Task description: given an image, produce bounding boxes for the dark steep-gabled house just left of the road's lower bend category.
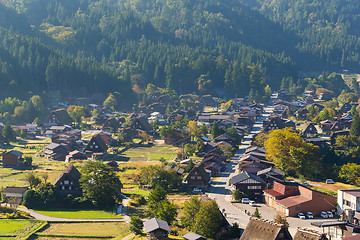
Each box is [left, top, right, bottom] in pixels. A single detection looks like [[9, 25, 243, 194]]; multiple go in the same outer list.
[[185, 163, 210, 190]]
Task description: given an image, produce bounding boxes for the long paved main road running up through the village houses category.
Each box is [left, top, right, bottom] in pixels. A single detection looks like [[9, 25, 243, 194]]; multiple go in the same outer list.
[[208, 94, 277, 228]]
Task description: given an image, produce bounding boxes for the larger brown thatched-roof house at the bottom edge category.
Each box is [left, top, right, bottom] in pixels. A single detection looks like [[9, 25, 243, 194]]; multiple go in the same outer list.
[[240, 218, 292, 240]]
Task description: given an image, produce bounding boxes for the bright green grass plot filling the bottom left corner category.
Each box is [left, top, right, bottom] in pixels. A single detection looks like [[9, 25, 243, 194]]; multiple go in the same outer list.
[[0, 219, 43, 239]]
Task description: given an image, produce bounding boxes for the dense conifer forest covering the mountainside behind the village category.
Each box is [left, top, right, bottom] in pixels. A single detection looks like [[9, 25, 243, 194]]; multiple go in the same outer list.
[[0, 0, 360, 101]]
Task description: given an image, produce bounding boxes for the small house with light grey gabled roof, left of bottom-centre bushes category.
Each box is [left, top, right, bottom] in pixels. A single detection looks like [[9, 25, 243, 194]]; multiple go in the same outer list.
[[144, 218, 171, 240]]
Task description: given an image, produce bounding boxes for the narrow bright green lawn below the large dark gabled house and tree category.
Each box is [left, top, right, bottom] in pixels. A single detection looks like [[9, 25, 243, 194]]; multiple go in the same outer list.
[[36, 210, 123, 219]]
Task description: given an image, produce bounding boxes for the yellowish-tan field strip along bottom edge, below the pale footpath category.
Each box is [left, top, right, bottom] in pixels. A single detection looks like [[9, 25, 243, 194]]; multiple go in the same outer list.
[[36, 222, 130, 239]]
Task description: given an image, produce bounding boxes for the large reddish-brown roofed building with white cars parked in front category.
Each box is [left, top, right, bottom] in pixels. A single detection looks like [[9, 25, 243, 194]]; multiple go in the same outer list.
[[264, 181, 336, 216]]
